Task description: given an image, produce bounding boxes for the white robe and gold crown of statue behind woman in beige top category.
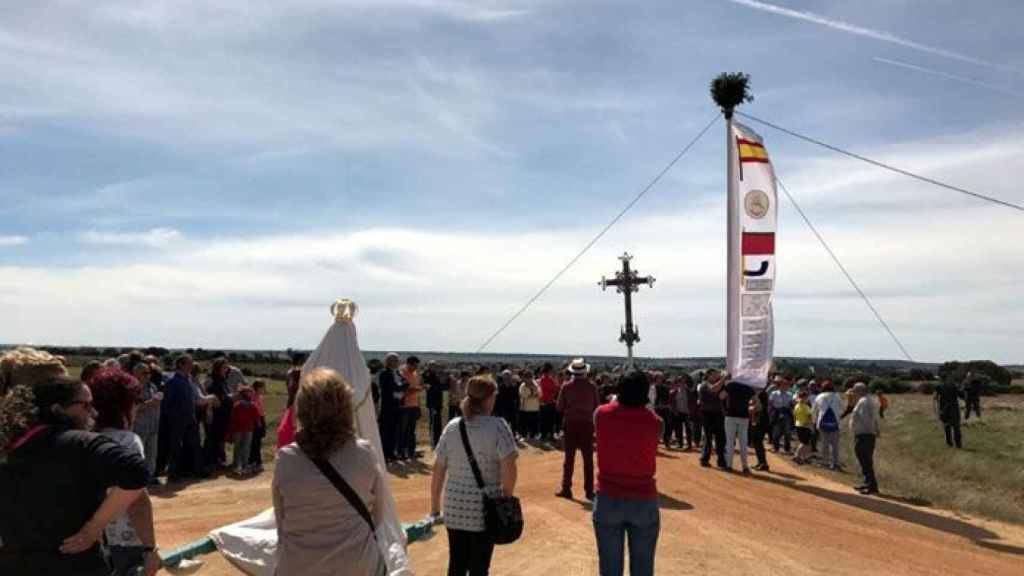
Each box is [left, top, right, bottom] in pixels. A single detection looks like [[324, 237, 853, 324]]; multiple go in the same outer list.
[[210, 300, 413, 576]]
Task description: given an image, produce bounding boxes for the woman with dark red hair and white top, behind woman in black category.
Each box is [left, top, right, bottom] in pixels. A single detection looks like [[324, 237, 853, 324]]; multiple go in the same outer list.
[[87, 368, 159, 576]]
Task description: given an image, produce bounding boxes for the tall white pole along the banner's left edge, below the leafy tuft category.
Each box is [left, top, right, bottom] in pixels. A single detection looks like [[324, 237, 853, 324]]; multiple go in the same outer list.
[[723, 109, 740, 374]]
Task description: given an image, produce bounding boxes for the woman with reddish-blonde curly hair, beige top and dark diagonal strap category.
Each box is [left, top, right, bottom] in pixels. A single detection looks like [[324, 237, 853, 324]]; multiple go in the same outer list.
[[271, 368, 387, 576]]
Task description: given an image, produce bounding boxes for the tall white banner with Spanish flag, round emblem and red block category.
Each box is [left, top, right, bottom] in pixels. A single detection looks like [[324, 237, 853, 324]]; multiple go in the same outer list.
[[726, 122, 778, 387]]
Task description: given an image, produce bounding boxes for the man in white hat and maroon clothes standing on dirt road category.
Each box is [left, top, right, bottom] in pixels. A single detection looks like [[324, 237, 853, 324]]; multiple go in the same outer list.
[[555, 358, 600, 500]]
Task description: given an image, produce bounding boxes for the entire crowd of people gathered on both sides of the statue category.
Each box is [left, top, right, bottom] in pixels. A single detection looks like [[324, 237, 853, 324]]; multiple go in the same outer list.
[[0, 340, 981, 576]]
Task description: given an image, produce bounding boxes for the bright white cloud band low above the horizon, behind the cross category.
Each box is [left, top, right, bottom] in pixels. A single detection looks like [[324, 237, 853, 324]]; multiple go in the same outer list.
[[0, 181, 1024, 361]]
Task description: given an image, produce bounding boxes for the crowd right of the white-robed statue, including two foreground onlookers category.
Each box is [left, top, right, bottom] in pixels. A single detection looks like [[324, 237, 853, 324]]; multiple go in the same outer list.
[[375, 354, 889, 576]]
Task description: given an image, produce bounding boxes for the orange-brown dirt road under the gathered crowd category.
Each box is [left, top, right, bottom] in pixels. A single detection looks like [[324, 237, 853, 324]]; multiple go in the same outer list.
[[154, 448, 1024, 576]]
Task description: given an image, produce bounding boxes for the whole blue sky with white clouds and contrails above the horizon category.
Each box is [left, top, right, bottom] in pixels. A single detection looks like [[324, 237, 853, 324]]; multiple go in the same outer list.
[[0, 0, 1024, 363]]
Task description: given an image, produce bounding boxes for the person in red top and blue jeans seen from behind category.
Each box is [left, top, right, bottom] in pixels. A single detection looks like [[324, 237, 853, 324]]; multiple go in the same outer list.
[[594, 371, 662, 576]]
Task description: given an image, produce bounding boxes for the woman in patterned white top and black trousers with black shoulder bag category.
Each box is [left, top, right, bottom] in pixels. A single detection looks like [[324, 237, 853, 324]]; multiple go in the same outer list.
[[430, 375, 518, 576]]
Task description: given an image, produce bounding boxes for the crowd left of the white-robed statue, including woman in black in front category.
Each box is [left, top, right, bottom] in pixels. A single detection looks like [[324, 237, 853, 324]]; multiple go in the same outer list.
[[0, 348, 266, 576]]
